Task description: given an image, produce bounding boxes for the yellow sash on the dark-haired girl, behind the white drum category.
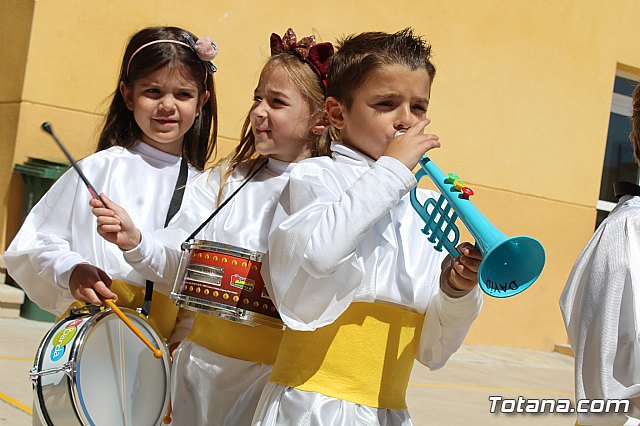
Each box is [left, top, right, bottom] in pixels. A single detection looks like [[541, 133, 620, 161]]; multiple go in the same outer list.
[[60, 280, 178, 342]]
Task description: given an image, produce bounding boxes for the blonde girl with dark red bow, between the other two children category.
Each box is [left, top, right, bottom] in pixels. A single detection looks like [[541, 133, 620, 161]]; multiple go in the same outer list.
[[92, 26, 333, 426]]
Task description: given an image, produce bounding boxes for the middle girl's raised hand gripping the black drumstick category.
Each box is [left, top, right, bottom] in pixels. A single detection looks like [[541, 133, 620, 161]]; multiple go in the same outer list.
[[89, 193, 142, 250]]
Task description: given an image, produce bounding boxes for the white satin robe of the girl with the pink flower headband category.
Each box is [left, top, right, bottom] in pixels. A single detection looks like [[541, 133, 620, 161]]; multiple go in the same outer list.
[[4, 143, 197, 315]]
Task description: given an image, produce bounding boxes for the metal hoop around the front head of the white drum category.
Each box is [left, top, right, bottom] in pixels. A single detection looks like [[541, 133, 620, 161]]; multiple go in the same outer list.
[[68, 308, 171, 424]]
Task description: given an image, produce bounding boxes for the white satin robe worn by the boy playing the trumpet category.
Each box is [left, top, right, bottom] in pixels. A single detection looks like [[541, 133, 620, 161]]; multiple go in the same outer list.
[[254, 143, 482, 426]]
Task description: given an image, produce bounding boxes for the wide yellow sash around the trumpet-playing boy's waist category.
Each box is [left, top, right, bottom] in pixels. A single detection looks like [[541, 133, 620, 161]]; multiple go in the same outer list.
[[269, 302, 424, 409]]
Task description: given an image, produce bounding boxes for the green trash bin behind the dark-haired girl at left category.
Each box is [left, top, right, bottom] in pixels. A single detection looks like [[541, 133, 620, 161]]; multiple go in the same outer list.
[[14, 157, 69, 322]]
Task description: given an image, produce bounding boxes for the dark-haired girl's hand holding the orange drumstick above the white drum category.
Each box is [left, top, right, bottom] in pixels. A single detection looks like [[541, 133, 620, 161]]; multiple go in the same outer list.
[[69, 263, 118, 306]]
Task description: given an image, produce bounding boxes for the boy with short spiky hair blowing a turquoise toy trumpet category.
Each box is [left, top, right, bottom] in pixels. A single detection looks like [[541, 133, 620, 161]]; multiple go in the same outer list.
[[253, 29, 482, 426]]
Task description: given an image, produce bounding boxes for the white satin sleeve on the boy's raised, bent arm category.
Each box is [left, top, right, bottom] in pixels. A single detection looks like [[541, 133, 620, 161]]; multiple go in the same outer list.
[[269, 157, 416, 330]]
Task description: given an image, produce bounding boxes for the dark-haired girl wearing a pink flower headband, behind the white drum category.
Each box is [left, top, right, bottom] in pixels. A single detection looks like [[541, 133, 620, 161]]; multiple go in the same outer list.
[[4, 22, 217, 380]]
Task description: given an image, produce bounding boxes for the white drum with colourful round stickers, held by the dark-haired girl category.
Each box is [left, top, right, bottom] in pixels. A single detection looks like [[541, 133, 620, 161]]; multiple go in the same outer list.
[[29, 308, 171, 426]]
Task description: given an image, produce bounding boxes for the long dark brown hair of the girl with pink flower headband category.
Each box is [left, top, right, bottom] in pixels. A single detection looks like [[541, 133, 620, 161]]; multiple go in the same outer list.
[[96, 27, 218, 170]]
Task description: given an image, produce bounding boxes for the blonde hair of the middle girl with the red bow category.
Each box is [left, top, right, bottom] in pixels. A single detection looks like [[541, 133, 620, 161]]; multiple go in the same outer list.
[[214, 52, 331, 204]]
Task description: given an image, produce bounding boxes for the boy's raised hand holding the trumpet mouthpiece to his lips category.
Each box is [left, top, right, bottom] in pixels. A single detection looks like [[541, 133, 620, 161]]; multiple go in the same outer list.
[[382, 117, 440, 170]]
